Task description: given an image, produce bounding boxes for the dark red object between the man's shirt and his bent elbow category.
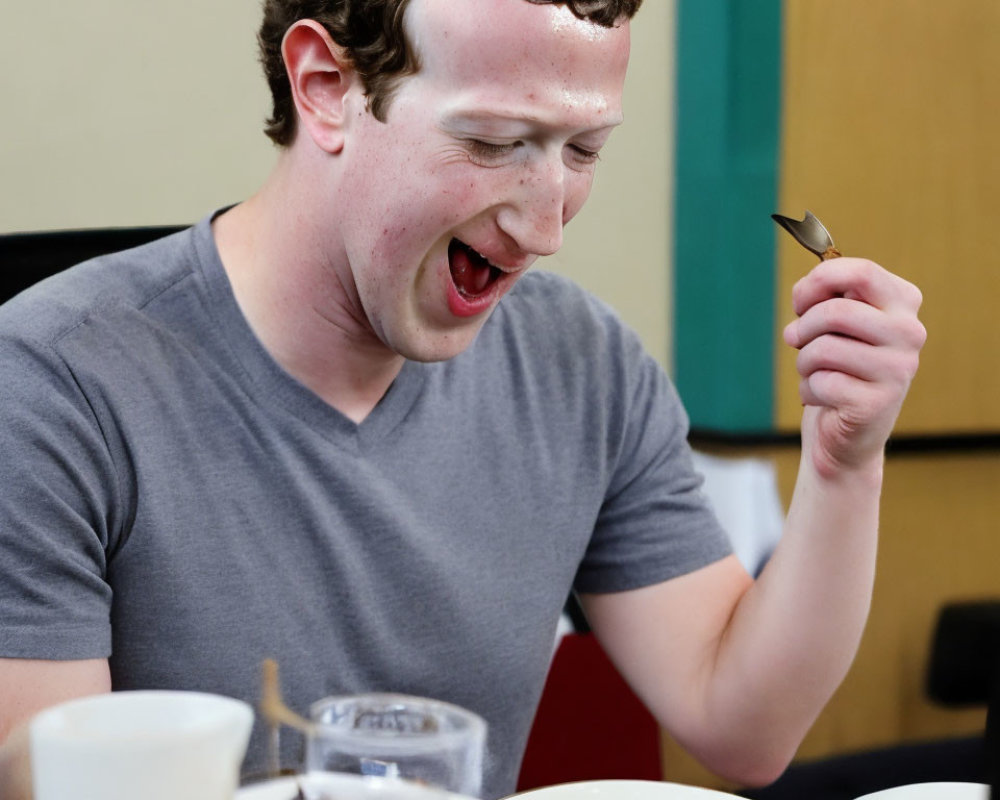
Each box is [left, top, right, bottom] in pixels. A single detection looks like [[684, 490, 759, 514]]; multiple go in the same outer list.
[[517, 633, 663, 791]]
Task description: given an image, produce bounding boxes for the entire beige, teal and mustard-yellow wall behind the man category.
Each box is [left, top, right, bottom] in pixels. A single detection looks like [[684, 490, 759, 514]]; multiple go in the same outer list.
[[0, 0, 1000, 785]]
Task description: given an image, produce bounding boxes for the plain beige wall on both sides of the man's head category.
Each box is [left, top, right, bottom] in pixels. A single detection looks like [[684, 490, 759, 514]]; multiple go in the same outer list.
[[0, 0, 674, 364]]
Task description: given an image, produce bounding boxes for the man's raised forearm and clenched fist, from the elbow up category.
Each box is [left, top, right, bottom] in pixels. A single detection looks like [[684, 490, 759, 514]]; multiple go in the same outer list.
[[699, 252, 927, 780]]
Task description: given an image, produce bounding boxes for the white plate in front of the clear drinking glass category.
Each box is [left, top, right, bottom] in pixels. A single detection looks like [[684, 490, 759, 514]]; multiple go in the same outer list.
[[236, 772, 471, 800]]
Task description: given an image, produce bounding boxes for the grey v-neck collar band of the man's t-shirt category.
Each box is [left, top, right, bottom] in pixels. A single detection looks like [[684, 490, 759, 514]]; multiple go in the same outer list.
[[193, 215, 427, 449]]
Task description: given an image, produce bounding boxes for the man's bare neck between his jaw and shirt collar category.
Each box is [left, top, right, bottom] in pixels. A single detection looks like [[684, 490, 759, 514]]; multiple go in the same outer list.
[[213, 150, 404, 423]]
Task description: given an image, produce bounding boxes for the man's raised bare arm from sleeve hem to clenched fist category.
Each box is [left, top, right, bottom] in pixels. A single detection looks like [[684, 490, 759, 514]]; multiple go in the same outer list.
[[582, 258, 925, 784]]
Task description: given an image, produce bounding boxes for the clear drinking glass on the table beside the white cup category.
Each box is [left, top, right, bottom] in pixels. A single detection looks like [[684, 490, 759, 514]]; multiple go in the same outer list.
[[306, 693, 486, 797]]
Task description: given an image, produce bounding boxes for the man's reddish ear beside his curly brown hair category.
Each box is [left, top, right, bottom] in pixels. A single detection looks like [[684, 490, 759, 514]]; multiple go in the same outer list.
[[281, 19, 359, 153]]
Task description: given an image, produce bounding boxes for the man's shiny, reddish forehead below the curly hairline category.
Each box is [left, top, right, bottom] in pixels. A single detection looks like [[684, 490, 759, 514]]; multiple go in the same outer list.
[[406, 0, 629, 124]]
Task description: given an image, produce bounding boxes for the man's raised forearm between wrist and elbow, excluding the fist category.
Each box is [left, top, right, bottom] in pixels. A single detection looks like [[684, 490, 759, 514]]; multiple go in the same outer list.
[[706, 455, 882, 782]]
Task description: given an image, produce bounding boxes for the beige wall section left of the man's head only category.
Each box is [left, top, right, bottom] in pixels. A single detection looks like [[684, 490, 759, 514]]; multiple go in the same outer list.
[[0, 0, 273, 231]]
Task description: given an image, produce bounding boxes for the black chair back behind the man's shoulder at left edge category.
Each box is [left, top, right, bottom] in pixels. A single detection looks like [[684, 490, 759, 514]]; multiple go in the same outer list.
[[0, 225, 185, 303]]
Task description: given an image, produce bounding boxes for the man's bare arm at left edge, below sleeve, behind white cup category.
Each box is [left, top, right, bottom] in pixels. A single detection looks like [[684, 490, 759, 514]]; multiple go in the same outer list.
[[0, 658, 111, 800]]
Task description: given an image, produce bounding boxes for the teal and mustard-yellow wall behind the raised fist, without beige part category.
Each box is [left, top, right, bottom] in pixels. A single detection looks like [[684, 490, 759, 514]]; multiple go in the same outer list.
[[665, 0, 1000, 798]]
